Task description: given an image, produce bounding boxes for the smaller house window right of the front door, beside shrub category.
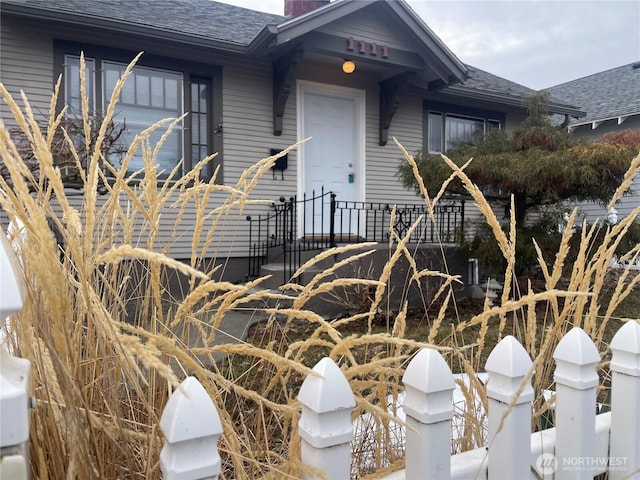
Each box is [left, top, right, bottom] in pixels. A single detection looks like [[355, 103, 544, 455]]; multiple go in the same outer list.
[[425, 103, 504, 153]]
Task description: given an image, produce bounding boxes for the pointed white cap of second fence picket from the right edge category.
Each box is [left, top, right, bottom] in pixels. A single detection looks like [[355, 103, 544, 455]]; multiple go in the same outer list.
[[553, 327, 600, 390]]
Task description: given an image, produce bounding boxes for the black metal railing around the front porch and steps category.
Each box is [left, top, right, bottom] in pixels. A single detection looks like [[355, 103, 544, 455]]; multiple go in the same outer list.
[[247, 189, 464, 283]]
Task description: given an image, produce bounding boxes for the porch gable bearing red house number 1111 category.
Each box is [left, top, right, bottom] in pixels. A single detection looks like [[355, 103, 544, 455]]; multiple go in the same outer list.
[[253, 0, 466, 90]]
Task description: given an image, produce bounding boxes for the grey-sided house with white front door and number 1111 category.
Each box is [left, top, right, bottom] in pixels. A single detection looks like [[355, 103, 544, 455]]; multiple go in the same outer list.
[[0, 0, 582, 280]]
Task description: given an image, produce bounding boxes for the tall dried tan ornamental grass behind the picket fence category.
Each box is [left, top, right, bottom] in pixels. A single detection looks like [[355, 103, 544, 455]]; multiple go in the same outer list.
[[0, 54, 640, 478]]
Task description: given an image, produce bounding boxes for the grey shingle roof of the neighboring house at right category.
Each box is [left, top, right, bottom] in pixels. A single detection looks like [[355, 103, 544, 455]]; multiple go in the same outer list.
[[547, 62, 640, 126]]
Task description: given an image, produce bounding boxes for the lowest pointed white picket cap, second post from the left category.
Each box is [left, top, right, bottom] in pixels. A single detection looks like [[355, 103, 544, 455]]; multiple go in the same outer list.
[[160, 377, 222, 443]]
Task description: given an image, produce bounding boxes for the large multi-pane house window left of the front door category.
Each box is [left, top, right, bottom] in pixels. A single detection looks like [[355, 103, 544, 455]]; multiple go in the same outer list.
[[56, 44, 222, 181]]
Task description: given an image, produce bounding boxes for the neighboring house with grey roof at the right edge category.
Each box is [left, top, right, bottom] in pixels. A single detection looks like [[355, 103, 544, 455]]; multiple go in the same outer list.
[[547, 62, 640, 222]]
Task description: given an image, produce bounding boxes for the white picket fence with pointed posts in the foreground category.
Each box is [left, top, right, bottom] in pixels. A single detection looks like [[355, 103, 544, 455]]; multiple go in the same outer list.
[[0, 235, 640, 480]]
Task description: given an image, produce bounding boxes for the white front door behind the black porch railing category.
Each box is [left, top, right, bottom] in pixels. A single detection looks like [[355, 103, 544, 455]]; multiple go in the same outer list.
[[299, 84, 364, 236]]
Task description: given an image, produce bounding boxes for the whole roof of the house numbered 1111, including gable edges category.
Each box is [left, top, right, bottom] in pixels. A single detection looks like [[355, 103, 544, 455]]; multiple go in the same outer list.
[[0, 0, 584, 116]]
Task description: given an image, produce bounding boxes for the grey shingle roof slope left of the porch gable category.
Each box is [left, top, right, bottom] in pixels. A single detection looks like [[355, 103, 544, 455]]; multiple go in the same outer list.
[[2, 0, 287, 46]]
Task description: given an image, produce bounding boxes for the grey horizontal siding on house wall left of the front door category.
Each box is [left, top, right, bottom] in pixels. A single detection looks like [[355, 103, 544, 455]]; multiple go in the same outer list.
[[0, 18, 276, 258]]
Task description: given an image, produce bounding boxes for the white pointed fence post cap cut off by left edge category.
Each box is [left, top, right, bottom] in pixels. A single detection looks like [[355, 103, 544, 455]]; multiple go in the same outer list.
[[0, 232, 27, 320]]
